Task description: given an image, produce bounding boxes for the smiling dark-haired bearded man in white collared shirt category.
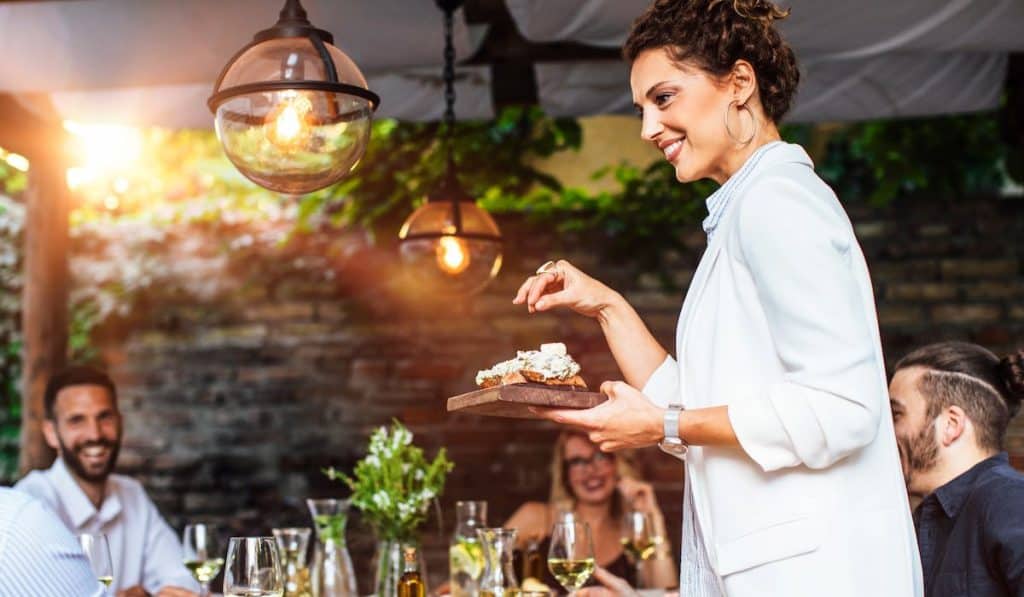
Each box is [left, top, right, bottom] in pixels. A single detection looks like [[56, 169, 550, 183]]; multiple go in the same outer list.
[[15, 367, 199, 597]]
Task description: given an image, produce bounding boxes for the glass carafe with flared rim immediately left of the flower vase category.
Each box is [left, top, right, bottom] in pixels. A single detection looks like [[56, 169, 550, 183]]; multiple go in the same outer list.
[[306, 500, 358, 597]]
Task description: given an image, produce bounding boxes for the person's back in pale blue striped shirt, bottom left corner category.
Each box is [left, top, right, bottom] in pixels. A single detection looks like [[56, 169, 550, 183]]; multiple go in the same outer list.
[[0, 487, 103, 597]]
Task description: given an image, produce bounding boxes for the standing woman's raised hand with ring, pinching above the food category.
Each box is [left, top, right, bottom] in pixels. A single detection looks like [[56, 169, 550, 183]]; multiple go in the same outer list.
[[512, 259, 617, 317]]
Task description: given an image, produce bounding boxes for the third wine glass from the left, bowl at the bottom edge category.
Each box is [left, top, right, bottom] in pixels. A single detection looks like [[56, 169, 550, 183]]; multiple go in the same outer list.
[[224, 537, 285, 597]]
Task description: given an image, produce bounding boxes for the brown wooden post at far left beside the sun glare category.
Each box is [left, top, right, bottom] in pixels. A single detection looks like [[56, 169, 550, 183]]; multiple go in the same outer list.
[[0, 95, 71, 474]]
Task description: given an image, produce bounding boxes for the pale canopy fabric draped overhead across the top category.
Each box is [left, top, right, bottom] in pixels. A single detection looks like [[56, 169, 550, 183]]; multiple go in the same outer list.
[[0, 0, 1024, 128]]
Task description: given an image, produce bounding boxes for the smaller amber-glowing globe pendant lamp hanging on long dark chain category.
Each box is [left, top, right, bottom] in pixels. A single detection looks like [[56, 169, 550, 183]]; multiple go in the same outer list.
[[398, 0, 502, 295]]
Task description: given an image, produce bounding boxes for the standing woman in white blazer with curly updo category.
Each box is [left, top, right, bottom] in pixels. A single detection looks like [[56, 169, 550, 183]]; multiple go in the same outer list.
[[514, 0, 922, 597]]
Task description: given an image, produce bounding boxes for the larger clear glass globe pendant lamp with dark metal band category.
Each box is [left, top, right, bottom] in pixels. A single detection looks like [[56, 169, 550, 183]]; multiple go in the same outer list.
[[207, 0, 380, 195]]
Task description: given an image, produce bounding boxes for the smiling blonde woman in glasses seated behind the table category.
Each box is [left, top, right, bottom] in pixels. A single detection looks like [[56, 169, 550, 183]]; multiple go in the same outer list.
[[505, 431, 679, 591]]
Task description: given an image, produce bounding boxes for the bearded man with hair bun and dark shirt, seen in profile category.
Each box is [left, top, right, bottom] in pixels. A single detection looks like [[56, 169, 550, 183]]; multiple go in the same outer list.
[[889, 342, 1024, 597]]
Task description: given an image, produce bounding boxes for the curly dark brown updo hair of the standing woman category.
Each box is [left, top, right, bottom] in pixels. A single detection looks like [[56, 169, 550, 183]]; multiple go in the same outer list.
[[623, 0, 800, 123]]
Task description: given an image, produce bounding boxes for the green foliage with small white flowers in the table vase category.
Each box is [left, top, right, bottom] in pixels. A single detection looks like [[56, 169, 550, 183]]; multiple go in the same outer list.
[[324, 421, 455, 541]]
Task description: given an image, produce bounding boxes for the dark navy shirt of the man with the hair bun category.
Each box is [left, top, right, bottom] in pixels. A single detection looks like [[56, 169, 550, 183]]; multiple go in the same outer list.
[[913, 453, 1024, 597]]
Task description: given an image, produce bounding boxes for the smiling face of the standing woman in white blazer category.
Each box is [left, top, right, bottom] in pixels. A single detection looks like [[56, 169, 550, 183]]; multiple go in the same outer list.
[[630, 47, 736, 182]]
